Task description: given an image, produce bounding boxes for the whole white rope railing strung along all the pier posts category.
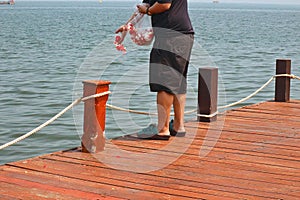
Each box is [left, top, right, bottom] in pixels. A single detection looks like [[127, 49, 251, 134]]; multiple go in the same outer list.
[[0, 74, 300, 150]]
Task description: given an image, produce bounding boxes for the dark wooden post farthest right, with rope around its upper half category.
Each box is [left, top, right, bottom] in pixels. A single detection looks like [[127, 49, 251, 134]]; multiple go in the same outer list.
[[275, 59, 291, 102]]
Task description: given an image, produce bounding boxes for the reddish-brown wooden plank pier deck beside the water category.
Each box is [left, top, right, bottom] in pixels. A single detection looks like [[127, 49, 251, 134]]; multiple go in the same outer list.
[[0, 100, 300, 200]]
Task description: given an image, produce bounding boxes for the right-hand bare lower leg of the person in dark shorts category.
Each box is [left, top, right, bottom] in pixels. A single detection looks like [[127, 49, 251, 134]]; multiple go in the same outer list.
[[173, 94, 186, 132]]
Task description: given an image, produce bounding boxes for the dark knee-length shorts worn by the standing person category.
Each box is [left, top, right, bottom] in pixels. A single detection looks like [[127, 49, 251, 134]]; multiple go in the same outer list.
[[149, 34, 194, 94]]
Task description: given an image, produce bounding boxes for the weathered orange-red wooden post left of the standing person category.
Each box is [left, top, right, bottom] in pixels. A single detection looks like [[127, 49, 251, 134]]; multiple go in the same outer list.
[[81, 81, 111, 153]]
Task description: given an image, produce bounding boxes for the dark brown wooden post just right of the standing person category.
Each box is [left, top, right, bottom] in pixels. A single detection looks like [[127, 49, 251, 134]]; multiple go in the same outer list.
[[197, 68, 218, 122]]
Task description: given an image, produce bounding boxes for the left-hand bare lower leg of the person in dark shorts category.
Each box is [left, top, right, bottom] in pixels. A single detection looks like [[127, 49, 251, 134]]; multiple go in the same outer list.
[[157, 91, 174, 135]]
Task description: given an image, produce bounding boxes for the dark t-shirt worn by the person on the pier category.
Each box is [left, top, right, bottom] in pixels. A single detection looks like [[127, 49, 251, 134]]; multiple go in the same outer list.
[[143, 0, 194, 34]]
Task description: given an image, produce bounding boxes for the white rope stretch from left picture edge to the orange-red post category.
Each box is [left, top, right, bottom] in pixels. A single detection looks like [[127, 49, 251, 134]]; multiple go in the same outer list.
[[0, 91, 111, 150]]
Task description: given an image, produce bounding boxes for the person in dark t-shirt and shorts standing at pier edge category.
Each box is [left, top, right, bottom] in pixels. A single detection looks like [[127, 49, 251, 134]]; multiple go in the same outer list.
[[116, 0, 194, 140]]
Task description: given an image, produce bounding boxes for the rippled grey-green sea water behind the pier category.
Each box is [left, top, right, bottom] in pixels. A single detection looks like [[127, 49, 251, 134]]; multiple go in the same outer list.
[[0, 1, 300, 164]]
